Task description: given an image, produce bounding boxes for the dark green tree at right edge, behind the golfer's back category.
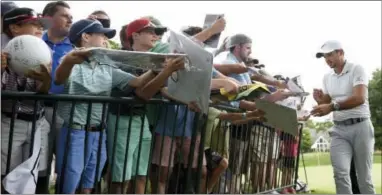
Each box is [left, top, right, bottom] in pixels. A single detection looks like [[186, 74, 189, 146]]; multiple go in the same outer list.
[[369, 69, 382, 150]]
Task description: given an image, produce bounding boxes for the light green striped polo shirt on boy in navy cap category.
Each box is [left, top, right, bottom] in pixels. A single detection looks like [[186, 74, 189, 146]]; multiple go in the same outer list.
[[58, 56, 135, 125]]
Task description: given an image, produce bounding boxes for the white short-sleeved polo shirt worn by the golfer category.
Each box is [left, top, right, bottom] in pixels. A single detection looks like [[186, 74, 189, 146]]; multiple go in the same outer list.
[[322, 62, 370, 121]]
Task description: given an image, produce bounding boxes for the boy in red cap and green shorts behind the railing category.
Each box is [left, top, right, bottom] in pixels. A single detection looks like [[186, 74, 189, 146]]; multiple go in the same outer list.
[[108, 18, 180, 193]]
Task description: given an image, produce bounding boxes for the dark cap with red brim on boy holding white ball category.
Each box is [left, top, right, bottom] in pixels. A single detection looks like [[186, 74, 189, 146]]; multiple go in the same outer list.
[[3, 8, 52, 29]]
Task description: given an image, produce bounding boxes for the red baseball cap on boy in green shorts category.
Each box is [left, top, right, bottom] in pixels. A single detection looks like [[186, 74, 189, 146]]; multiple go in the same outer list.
[[126, 18, 167, 38]]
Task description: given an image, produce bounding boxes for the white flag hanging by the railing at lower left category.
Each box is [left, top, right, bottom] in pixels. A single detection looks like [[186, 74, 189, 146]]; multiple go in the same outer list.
[[3, 128, 41, 194]]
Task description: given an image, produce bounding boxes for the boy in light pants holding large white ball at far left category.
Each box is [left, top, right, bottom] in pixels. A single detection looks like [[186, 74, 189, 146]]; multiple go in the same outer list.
[[1, 8, 52, 193]]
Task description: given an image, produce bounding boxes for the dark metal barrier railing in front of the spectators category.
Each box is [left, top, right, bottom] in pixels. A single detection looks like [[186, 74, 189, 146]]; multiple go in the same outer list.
[[1, 91, 301, 194]]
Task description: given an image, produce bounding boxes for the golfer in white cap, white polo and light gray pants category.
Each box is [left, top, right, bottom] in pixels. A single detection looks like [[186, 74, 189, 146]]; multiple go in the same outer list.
[[311, 41, 375, 194]]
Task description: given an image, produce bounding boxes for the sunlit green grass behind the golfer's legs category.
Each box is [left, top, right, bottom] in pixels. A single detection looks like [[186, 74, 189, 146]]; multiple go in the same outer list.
[[299, 152, 382, 194]]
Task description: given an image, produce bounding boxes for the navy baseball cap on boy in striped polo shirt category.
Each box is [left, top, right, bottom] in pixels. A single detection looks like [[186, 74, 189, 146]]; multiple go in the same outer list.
[[69, 19, 117, 43]]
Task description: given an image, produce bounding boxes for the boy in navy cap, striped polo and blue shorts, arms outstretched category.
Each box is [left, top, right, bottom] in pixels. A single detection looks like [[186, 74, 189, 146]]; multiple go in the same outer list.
[[55, 19, 187, 193]]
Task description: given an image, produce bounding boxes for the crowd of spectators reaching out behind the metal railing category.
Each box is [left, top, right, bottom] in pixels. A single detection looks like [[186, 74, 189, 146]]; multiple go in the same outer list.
[[1, 1, 307, 194]]
